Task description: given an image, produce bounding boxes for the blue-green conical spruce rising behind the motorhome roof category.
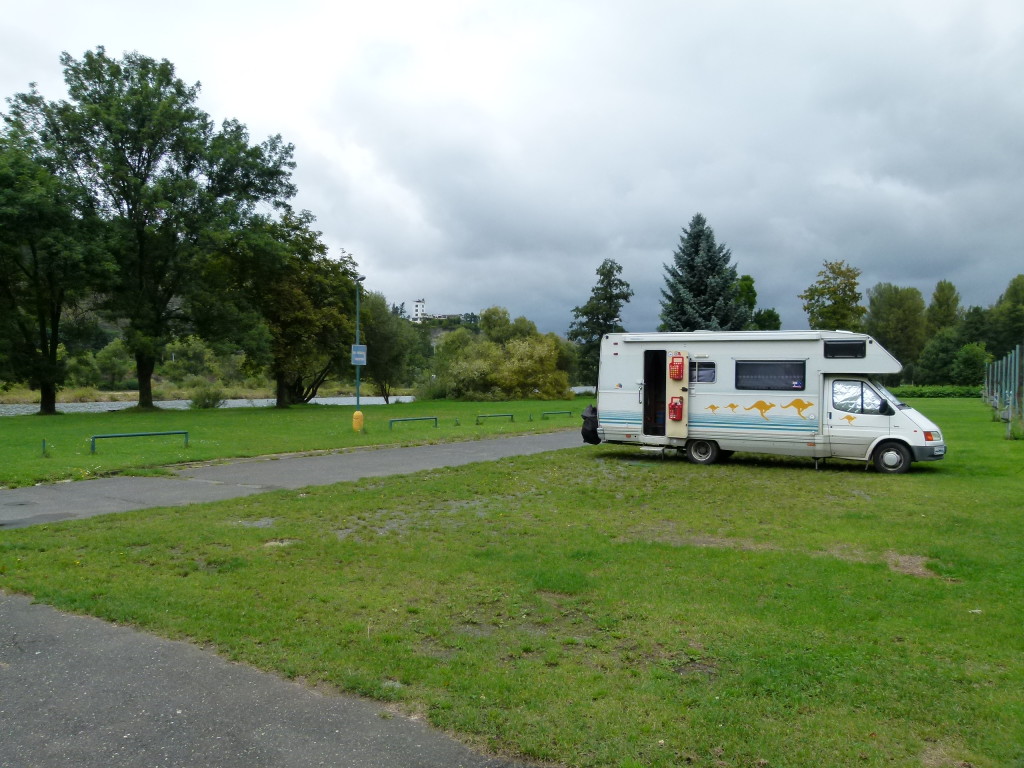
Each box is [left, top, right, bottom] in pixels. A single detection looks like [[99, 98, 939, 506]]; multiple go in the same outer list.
[[658, 213, 751, 331]]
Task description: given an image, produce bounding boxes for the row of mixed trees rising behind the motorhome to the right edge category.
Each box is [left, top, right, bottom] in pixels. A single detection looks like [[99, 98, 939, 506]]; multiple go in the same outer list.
[[568, 213, 1024, 386]]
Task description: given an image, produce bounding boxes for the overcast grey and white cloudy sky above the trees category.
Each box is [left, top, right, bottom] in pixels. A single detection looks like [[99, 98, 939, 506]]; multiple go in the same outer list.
[[0, 0, 1024, 333]]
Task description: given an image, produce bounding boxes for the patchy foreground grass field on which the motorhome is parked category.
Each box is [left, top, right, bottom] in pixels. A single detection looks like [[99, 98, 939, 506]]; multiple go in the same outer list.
[[0, 400, 1024, 768]]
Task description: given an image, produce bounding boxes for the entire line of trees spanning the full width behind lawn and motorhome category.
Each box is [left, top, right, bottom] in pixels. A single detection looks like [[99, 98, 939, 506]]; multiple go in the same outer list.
[[0, 47, 1024, 414]]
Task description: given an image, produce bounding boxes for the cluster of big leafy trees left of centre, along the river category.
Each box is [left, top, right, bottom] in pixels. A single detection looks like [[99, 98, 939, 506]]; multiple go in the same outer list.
[[0, 47, 444, 414]]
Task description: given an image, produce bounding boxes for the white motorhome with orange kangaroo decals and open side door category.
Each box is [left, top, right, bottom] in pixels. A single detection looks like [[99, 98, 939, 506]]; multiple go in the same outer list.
[[597, 331, 946, 473]]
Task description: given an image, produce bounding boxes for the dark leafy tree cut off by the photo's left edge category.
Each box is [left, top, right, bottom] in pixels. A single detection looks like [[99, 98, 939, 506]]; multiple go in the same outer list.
[[0, 123, 108, 414]]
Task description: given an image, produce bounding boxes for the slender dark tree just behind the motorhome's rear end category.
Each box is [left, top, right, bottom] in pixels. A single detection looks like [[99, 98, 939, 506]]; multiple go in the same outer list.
[[567, 259, 633, 386]]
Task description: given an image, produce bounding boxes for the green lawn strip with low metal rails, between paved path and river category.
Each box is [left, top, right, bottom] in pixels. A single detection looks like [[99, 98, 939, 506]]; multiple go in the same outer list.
[[0, 398, 590, 486]]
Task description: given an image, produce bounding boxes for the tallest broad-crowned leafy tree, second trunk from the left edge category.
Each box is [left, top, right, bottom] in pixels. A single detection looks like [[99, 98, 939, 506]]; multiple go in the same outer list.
[[11, 47, 294, 407]]
